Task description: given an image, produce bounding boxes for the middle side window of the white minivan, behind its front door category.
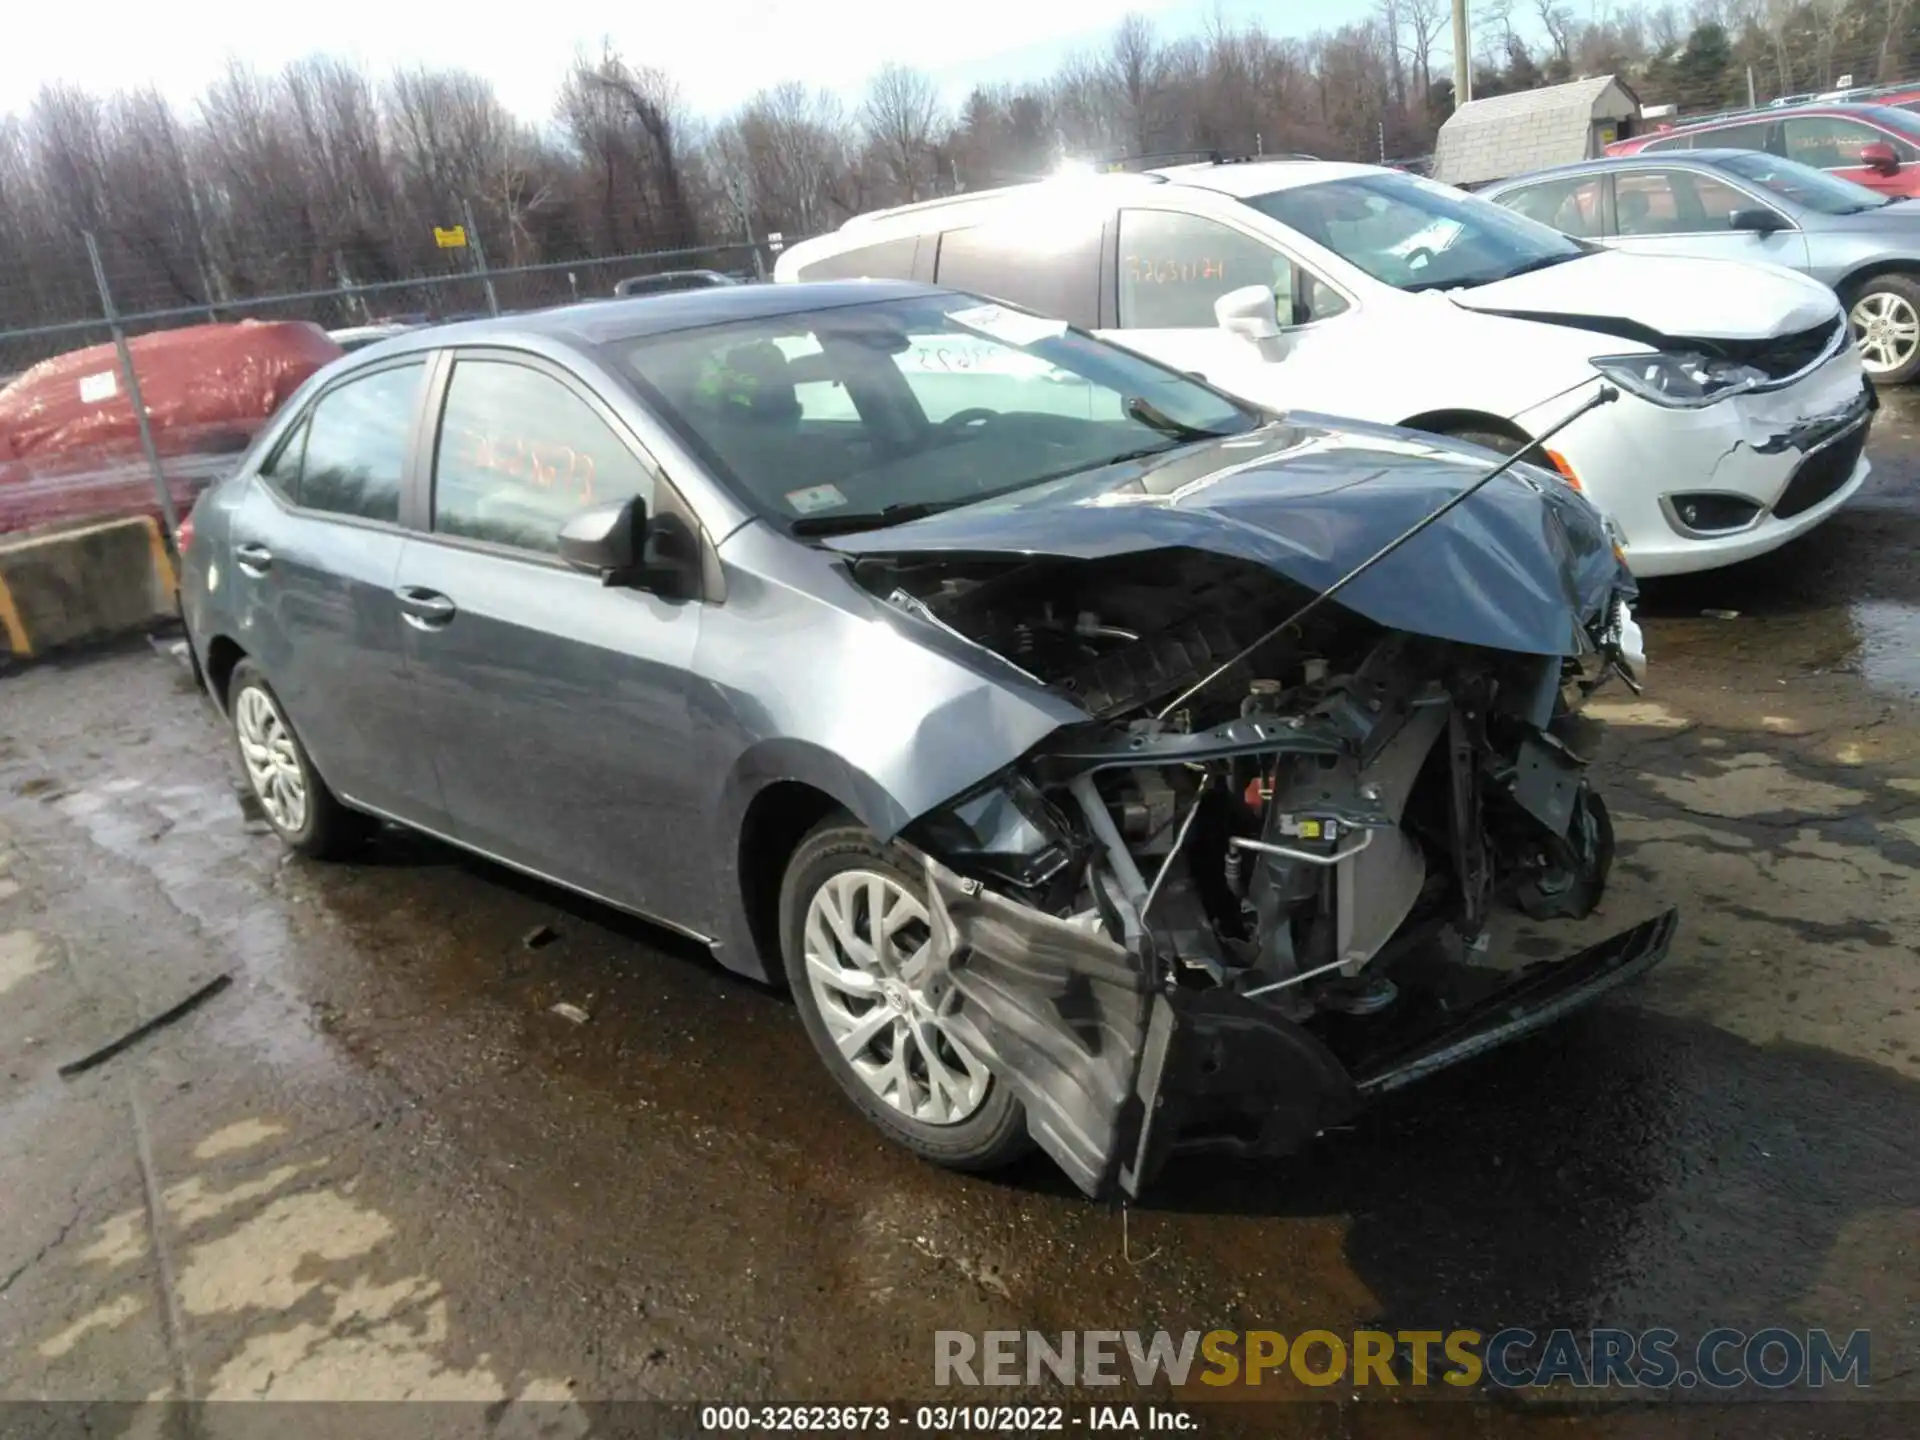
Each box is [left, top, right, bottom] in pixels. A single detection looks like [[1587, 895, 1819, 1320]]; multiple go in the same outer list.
[[933, 211, 1102, 330]]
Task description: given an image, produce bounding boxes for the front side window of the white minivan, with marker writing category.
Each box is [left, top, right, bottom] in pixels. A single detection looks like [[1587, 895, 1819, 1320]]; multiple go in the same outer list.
[[1119, 209, 1346, 330]]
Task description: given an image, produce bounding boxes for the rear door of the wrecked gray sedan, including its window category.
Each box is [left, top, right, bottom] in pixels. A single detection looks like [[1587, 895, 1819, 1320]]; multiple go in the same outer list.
[[219, 355, 440, 828]]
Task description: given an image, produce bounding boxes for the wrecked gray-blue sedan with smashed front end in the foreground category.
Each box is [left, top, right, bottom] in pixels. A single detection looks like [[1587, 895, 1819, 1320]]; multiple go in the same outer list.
[[182, 282, 1674, 1194]]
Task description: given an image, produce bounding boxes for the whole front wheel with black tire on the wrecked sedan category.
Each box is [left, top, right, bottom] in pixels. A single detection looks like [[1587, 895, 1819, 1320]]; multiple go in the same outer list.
[[780, 816, 1031, 1171]]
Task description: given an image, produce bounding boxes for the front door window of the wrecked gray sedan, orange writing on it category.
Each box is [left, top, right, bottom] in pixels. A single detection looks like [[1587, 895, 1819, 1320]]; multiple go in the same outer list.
[[434, 359, 653, 555]]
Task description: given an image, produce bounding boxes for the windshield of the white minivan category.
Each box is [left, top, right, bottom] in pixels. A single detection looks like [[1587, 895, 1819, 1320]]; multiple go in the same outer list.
[[1246, 171, 1586, 290]]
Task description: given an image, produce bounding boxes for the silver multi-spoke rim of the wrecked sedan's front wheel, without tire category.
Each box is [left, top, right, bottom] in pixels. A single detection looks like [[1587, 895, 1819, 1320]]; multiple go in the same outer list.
[[803, 870, 991, 1125]]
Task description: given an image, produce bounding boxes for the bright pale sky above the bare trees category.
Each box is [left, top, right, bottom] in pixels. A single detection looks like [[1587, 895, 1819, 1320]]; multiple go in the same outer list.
[[0, 0, 1413, 121]]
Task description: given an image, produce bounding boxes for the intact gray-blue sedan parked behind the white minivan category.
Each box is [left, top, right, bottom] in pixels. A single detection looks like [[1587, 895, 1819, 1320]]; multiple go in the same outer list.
[[1482, 150, 1920, 384]]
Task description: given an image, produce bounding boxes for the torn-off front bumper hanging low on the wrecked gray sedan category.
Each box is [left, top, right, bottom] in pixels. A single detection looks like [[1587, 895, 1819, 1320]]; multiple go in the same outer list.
[[924, 856, 1678, 1196]]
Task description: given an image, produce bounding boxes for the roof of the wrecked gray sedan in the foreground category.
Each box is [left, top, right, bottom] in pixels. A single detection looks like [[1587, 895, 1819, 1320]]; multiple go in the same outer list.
[[361, 280, 948, 357]]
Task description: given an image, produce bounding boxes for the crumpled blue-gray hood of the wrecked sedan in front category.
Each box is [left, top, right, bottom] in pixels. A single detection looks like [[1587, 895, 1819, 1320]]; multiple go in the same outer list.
[[822, 415, 1632, 655]]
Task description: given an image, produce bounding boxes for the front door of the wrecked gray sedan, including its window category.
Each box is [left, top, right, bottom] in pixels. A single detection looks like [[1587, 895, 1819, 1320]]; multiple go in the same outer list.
[[394, 349, 707, 924]]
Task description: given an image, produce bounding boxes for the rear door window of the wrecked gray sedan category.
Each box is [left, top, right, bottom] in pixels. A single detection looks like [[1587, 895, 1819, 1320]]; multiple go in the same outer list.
[[298, 361, 426, 522]]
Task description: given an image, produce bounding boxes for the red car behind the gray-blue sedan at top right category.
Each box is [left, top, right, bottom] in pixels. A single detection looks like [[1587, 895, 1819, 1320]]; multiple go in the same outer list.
[[1607, 104, 1920, 196]]
